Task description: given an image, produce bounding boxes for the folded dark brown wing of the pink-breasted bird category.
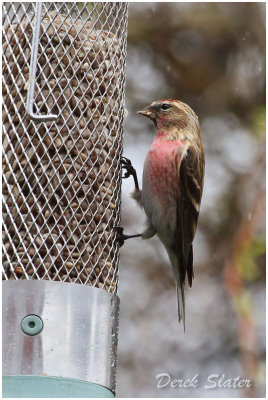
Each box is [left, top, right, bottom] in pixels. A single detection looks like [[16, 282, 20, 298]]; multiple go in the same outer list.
[[174, 144, 204, 287]]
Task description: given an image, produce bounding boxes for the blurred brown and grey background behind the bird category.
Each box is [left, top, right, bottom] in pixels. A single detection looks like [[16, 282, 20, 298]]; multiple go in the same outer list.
[[117, 2, 265, 397]]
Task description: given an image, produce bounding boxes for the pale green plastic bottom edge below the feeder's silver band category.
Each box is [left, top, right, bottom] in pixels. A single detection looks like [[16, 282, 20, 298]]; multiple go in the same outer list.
[[2, 375, 114, 398]]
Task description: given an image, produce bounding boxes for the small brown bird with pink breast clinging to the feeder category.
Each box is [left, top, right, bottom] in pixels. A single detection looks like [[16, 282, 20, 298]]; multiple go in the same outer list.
[[120, 99, 205, 331]]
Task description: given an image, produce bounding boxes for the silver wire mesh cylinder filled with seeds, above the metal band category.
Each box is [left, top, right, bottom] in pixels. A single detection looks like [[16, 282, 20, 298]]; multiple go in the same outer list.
[[3, 2, 127, 292]]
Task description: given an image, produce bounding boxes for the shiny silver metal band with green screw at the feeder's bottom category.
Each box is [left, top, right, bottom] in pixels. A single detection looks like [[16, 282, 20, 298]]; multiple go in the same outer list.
[[2, 279, 119, 397]]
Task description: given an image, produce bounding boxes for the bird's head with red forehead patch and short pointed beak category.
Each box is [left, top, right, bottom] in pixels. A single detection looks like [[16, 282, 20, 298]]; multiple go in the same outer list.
[[138, 99, 199, 134]]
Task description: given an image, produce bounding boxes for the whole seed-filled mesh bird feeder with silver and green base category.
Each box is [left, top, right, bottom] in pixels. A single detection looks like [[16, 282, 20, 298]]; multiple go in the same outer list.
[[2, 2, 127, 397]]
